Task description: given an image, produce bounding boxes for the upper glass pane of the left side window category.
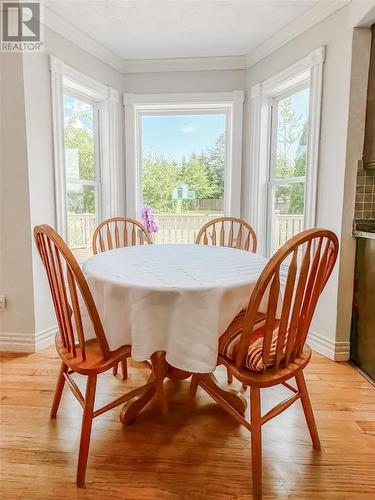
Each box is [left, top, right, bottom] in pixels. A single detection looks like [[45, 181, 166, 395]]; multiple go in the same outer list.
[[64, 95, 95, 180]]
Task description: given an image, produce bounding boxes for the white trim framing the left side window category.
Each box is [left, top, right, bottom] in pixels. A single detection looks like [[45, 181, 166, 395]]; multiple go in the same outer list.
[[50, 56, 119, 239]]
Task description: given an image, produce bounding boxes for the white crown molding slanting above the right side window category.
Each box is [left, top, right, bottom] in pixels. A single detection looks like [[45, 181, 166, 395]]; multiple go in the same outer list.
[[246, 0, 351, 68]]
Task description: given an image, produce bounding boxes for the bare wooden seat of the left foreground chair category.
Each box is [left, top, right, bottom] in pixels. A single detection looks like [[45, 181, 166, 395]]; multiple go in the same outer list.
[[55, 333, 131, 375]]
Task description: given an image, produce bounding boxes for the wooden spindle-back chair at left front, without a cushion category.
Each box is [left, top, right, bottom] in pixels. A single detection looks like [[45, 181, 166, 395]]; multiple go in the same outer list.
[[34, 225, 153, 486]]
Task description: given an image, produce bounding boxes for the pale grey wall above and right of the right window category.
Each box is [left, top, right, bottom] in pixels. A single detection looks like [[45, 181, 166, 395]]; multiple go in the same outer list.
[[242, 2, 369, 359]]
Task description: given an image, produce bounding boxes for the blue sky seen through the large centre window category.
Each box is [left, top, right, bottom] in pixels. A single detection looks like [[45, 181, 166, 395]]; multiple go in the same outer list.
[[142, 114, 225, 162]]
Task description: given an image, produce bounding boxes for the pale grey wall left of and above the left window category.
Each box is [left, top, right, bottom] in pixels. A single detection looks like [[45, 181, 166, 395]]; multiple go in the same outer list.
[[0, 29, 124, 350]]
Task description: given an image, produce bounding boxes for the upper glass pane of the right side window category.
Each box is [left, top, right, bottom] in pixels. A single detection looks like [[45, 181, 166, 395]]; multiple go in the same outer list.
[[275, 88, 309, 178]]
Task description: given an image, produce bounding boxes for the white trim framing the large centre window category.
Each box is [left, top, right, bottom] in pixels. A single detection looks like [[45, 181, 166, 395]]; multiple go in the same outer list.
[[123, 90, 244, 217]]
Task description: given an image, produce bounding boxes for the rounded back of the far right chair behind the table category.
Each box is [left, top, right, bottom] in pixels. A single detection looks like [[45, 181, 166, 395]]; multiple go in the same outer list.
[[195, 217, 257, 253]]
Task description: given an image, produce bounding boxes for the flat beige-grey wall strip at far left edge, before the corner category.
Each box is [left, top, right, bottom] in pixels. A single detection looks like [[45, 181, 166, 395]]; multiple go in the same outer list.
[[0, 53, 34, 350]]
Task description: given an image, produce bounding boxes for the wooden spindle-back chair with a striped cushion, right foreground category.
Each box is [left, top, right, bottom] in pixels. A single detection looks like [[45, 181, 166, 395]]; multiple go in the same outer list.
[[191, 229, 338, 500]]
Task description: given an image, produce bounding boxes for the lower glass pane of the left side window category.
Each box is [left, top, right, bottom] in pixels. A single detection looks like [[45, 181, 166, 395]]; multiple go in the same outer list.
[[66, 183, 97, 256]]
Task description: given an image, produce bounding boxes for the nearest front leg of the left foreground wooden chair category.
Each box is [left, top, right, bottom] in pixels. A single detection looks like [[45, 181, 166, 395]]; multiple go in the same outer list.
[[76, 375, 97, 487]]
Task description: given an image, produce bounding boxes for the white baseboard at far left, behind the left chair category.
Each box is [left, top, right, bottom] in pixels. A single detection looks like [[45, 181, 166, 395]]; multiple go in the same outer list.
[[0, 326, 57, 352]]
